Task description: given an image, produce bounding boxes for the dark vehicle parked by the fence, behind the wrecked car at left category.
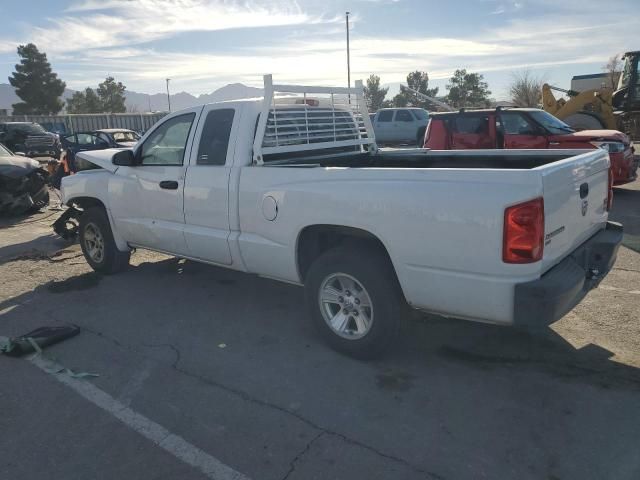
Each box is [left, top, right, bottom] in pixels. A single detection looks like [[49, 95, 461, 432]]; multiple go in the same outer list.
[[0, 122, 60, 158]]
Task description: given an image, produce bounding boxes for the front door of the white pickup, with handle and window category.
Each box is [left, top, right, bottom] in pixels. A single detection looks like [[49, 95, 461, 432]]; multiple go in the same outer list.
[[111, 106, 202, 255]]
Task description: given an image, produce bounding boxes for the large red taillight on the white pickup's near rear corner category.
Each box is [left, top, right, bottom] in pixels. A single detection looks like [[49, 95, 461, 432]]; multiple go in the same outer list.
[[502, 197, 544, 263]]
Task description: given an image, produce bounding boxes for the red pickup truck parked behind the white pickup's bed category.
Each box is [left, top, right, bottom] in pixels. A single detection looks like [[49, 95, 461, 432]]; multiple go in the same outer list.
[[424, 107, 638, 185]]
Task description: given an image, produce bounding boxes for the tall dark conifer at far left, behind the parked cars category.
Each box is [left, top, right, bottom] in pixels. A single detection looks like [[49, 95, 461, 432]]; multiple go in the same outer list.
[[9, 43, 66, 115]]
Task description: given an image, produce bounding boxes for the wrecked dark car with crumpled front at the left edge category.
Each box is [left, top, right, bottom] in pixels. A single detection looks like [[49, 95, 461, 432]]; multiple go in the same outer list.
[[0, 144, 49, 215]]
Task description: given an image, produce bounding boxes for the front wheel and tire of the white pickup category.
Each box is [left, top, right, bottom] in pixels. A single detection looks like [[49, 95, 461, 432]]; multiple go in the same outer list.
[[79, 207, 131, 275]]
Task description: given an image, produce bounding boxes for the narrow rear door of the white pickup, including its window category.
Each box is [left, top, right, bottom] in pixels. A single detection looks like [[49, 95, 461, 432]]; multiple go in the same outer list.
[[184, 105, 239, 265]]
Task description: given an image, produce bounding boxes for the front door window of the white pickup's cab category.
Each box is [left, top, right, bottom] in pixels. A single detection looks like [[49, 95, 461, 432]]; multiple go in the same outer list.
[[140, 113, 196, 166]]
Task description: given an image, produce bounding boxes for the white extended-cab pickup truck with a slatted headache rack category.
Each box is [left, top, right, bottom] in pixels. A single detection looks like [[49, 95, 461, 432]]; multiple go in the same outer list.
[[62, 76, 622, 357]]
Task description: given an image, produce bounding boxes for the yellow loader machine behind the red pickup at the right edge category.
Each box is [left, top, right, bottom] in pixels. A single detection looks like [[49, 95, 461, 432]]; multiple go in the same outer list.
[[542, 50, 640, 142]]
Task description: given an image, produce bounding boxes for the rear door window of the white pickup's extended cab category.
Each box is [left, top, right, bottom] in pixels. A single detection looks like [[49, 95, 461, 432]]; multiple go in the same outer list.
[[197, 108, 235, 165]]
